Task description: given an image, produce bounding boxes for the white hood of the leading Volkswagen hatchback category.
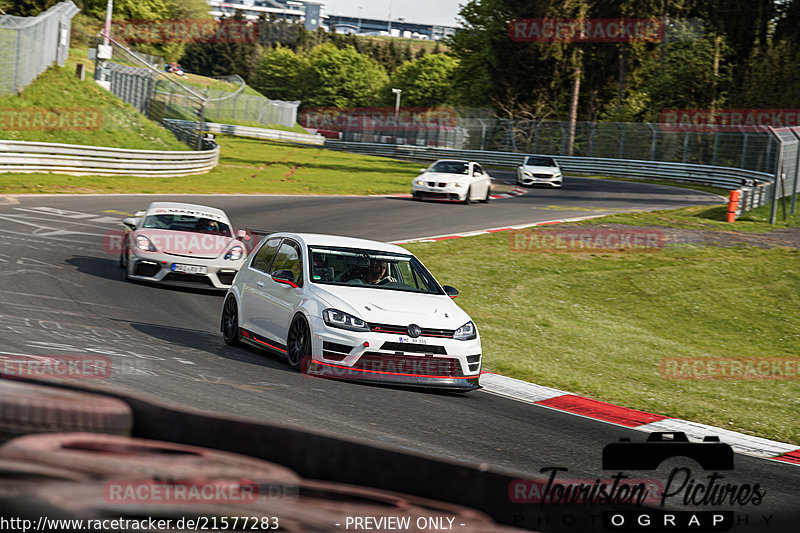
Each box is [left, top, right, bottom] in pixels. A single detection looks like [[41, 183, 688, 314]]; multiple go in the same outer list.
[[304, 283, 470, 329]]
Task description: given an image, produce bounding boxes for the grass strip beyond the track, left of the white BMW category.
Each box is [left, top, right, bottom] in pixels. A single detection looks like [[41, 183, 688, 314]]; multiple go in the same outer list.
[[0, 135, 419, 194]]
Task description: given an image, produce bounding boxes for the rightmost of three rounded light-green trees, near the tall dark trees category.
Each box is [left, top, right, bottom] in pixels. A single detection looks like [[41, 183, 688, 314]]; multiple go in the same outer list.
[[391, 54, 458, 107]]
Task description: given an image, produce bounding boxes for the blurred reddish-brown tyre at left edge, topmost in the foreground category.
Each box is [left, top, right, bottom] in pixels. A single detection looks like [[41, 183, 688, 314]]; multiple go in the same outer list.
[[0, 379, 133, 441]]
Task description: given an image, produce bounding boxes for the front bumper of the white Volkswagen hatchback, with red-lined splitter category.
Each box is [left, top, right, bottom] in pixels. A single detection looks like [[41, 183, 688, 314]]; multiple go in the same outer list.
[[307, 319, 481, 391]]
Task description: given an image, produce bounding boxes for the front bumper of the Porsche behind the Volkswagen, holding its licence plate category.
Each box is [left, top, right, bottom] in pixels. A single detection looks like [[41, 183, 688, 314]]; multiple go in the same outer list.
[[127, 252, 244, 290]]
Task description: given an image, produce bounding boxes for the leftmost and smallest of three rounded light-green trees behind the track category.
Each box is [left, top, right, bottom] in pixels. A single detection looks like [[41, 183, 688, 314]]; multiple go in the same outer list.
[[250, 45, 310, 101]]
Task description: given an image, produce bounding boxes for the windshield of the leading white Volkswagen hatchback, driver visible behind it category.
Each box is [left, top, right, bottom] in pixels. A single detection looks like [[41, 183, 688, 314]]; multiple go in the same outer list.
[[309, 246, 444, 294]]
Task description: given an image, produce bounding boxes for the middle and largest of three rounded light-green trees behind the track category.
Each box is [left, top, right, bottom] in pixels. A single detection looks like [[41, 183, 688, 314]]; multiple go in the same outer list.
[[303, 43, 389, 108]]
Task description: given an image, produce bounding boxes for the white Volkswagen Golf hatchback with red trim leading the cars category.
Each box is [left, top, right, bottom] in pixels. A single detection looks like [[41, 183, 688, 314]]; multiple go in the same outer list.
[[220, 233, 481, 391]]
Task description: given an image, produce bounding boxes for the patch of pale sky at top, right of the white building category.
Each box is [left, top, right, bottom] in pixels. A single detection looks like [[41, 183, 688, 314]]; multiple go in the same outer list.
[[319, 0, 467, 26]]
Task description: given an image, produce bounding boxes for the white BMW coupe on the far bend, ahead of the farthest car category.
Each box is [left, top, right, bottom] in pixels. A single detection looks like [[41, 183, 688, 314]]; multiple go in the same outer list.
[[411, 159, 492, 204]]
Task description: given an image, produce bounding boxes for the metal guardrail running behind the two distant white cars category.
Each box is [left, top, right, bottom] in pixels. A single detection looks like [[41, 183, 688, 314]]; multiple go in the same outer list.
[[325, 139, 775, 214]]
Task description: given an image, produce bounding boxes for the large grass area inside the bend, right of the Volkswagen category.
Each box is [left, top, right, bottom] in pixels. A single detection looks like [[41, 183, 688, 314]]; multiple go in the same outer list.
[[407, 210, 800, 444]]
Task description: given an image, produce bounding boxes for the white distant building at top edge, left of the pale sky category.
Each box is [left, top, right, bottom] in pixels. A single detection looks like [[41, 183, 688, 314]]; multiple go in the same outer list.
[[207, 0, 324, 31]]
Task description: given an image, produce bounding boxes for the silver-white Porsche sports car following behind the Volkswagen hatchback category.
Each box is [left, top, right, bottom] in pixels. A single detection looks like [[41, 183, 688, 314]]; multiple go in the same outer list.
[[120, 202, 249, 289]]
